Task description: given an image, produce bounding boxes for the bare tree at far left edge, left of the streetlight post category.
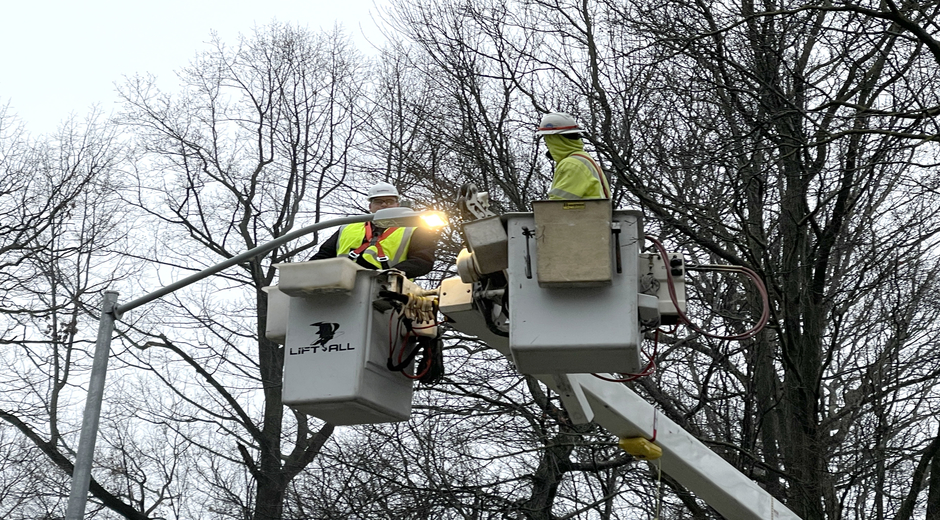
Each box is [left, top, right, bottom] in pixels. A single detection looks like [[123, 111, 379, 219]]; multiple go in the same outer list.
[[0, 107, 141, 518]]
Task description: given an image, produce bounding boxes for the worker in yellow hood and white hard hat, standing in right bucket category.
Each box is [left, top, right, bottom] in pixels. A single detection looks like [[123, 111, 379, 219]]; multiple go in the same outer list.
[[536, 112, 610, 200]]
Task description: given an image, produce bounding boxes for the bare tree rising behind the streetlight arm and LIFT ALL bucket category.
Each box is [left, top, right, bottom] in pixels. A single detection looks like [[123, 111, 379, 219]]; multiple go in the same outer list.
[[114, 24, 365, 519]]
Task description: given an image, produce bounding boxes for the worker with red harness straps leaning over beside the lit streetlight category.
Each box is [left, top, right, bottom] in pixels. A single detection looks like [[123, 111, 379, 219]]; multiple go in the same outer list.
[[311, 182, 437, 278]]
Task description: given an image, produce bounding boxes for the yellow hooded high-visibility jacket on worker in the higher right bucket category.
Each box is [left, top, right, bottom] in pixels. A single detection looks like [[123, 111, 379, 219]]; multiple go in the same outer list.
[[545, 134, 610, 200]]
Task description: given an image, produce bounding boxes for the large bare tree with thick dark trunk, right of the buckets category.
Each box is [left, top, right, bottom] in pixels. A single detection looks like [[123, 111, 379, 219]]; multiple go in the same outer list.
[[592, 6, 936, 518]]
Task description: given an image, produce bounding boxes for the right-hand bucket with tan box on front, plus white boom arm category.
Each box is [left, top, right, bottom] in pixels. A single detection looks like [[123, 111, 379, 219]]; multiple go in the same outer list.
[[440, 192, 799, 520]]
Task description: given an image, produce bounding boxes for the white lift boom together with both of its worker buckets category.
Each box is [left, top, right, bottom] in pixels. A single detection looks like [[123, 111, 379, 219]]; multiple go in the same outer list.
[[267, 196, 799, 520]]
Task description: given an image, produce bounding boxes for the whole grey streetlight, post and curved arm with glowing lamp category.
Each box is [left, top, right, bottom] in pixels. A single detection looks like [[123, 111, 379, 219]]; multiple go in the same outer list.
[[65, 208, 448, 520]]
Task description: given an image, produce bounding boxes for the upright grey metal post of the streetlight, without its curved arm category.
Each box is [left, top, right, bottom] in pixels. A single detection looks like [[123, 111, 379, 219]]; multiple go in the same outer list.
[[65, 291, 118, 520]]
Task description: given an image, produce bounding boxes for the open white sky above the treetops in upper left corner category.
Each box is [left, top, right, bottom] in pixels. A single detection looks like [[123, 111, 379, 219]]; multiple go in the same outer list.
[[0, 0, 382, 135]]
